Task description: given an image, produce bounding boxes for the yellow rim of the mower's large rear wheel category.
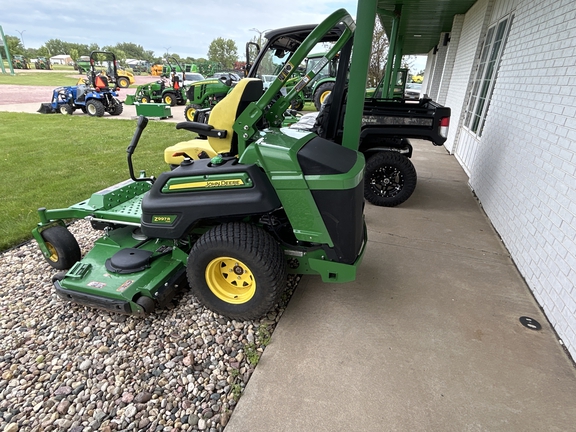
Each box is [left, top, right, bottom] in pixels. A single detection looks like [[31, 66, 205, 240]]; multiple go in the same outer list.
[[205, 257, 256, 304]]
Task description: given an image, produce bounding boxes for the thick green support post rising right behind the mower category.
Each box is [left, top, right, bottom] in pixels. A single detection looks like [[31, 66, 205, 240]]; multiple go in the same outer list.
[[342, 0, 378, 150]]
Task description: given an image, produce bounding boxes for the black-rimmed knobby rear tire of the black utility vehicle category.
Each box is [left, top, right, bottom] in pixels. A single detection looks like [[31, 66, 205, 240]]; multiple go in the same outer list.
[[364, 151, 417, 207]]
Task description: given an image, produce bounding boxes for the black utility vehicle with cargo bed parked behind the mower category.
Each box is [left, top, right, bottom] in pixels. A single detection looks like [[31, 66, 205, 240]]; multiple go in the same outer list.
[[242, 25, 450, 207]]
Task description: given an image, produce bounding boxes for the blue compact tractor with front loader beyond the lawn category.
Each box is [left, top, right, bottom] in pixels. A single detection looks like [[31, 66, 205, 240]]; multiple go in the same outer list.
[[38, 51, 124, 117]]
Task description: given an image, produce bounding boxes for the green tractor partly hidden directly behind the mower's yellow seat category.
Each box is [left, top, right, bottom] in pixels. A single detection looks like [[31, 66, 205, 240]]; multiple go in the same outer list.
[[184, 73, 240, 123]]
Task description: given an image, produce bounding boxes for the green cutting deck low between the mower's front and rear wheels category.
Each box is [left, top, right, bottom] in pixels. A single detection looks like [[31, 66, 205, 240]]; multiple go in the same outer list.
[[55, 226, 188, 314]]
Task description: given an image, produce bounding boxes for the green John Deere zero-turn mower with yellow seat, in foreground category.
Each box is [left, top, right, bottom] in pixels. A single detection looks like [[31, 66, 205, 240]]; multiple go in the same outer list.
[[33, 9, 367, 319]]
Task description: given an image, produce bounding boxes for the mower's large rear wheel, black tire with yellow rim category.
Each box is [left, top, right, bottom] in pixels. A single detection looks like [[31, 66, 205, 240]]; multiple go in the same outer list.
[[186, 222, 286, 320]]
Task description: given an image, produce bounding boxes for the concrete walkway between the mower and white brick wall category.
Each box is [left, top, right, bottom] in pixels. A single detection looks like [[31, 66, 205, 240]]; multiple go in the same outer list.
[[226, 141, 576, 432]]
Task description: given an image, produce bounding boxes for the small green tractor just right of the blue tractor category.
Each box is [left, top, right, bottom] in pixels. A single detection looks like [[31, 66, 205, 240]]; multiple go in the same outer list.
[[134, 57, 186, 106]]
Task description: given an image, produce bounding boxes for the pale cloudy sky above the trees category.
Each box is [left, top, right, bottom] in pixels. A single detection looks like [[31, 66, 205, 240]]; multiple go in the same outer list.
[[0, 0, 425, 69]]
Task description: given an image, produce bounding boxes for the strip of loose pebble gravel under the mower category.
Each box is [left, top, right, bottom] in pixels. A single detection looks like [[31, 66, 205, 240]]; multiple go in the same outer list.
[[0, 221, 299, 432]]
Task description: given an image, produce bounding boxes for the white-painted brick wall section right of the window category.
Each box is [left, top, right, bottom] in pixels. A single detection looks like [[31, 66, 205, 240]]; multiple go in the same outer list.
[[468, 0, 576, 358]]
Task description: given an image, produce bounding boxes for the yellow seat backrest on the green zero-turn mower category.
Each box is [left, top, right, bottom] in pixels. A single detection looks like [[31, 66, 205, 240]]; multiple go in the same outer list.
[[208, 78, 264, 155]]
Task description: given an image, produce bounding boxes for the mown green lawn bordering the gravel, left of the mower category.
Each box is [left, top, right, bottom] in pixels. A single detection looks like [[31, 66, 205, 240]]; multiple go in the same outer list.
[[0, 112, 192, 251]]
